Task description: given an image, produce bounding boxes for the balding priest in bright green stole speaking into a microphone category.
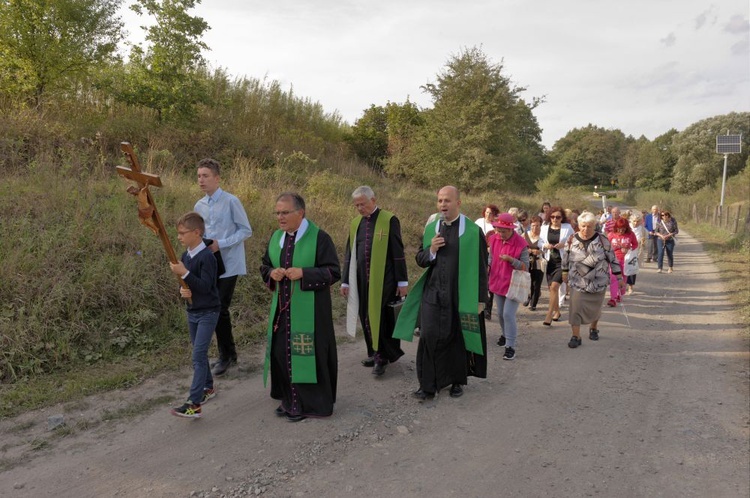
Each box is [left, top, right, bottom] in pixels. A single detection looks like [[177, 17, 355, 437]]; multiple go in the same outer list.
[[394, 186, 488, 399]]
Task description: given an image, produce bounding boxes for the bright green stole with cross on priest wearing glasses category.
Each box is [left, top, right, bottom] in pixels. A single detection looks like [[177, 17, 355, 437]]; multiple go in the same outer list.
[[263, 220, 318, 386]]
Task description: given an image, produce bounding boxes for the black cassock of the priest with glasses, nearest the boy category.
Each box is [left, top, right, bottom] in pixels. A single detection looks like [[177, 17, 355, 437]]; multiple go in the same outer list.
[[260, 230, 341, 417]]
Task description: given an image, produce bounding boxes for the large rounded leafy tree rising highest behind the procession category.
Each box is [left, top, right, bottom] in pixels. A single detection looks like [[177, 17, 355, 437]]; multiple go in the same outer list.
[[389, 47, 543, 190]]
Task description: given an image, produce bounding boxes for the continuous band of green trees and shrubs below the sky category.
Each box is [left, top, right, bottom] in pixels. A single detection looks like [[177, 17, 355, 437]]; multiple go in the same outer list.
[[0, 0, 750, 193]]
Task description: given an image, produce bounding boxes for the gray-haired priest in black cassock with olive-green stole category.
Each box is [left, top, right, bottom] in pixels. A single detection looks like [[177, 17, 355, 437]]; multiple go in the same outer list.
[[341, 185, 409, 377]]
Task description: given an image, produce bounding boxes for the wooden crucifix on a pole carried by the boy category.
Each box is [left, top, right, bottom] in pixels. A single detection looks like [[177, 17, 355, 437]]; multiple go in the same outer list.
[[117, 142, 190, 302]]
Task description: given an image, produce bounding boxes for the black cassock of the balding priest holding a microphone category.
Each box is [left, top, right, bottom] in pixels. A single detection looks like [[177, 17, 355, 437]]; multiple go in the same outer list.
[[417, 219, 487, 393]]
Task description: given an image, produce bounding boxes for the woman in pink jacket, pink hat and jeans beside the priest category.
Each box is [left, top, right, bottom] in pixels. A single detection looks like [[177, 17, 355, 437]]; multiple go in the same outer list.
[[488, 213, 529, 360]]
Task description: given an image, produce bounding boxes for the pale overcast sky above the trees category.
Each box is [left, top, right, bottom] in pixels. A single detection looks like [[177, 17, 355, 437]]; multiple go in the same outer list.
[[123, 0, 750, 148]]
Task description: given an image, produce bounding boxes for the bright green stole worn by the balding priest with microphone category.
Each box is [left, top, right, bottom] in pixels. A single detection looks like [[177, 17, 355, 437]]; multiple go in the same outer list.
[[393, 215, 484, 355]]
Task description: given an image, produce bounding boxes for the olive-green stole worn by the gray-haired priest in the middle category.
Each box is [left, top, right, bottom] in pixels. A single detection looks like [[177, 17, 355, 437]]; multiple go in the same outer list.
[[349, 209, 393, 351]]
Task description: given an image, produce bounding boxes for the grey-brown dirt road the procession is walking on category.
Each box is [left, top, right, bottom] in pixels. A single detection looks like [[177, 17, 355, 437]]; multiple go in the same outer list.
[[0, 234, 750, 498]]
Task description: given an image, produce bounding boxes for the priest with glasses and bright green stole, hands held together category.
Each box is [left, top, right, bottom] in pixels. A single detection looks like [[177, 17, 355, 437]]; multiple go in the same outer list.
[[260, 192, 341, 422]]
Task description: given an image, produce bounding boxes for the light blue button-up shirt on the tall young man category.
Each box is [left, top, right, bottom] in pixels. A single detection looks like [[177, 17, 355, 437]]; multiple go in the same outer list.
[[195, 188, 253, 278]]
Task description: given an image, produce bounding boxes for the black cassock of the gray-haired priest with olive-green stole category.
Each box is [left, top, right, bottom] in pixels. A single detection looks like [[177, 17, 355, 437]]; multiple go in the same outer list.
[[342, 209, 409, 362]]
